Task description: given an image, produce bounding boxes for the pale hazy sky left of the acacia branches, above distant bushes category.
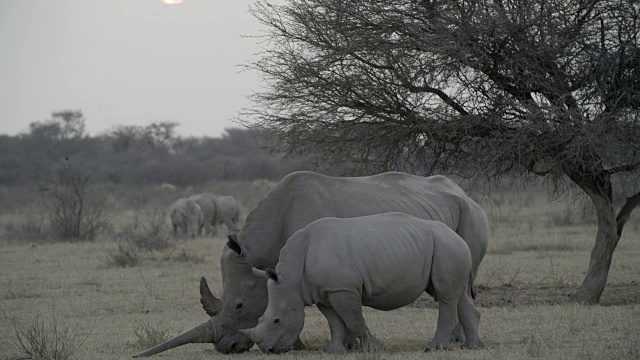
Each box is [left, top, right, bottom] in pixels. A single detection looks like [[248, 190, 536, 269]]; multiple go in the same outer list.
[[0, 0, 270, 136]]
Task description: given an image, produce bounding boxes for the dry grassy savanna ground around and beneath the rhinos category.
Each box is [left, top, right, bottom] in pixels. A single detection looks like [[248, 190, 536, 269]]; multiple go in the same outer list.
[[0, 182, 640, 360]]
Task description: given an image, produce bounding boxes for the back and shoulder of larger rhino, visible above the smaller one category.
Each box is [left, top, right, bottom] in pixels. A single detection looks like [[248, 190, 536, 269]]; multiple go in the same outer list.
[[238, 171, 471, 266]]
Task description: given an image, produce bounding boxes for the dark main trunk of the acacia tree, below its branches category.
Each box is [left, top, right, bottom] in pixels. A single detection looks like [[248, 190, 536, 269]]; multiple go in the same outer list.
[[576, 181, 620, 304]]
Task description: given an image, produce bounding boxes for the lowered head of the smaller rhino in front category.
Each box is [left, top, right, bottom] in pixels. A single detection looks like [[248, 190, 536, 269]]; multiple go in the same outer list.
[[240, 269, 304, 354]]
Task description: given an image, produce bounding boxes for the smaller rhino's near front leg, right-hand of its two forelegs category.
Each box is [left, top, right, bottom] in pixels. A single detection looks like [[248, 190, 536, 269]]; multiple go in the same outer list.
[[328, 291, 381, 351]]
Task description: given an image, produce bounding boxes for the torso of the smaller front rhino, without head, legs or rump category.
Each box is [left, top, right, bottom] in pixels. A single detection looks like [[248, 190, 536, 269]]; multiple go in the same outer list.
[[277, 213, 444, 310]]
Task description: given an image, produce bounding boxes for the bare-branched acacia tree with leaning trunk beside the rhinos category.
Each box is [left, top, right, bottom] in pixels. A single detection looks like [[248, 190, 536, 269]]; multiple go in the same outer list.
[[244, 0, 640, 302]]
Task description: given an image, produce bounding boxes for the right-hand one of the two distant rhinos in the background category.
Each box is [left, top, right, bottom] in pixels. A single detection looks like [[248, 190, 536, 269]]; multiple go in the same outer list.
[[189, 193, 240, 236]]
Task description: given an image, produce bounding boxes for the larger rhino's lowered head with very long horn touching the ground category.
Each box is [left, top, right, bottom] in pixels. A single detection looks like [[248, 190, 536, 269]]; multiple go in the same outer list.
[[135, 234, 268, 357]]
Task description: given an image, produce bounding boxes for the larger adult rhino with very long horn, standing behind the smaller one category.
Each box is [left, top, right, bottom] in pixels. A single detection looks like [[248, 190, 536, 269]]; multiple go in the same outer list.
[[132, 171, 489, 356]]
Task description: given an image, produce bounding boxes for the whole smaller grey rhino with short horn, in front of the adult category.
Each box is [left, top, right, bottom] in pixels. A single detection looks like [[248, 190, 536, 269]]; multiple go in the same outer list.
[[241, 213, 484, 353]]
